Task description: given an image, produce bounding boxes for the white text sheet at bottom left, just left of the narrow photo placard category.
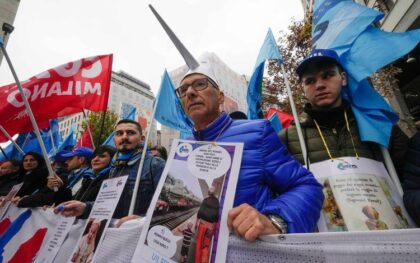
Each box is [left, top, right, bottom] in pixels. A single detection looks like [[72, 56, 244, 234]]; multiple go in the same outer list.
[[35, 212, 76, 263]]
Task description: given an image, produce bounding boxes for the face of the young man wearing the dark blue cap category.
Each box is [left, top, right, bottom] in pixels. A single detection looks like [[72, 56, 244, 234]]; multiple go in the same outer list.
[[302, 66, 347, 109]]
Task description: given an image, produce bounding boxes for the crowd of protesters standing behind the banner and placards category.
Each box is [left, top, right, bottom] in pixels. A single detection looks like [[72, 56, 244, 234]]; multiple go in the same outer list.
[[0, 47, 420, 243]]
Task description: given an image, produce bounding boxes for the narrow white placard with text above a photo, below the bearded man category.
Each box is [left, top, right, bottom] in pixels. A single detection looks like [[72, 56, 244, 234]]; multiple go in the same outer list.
[[69, 176, 127, 263]]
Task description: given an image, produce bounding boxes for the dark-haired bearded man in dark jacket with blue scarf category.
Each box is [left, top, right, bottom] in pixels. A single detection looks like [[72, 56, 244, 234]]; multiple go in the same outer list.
[[55, 119, 165, 225]]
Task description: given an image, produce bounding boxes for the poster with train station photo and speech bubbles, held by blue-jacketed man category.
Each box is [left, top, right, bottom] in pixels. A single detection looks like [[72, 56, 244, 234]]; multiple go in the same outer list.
[[132, 140, 243, 263]]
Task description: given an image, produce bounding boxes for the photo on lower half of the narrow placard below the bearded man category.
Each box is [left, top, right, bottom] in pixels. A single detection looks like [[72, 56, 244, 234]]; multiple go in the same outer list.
[[70, 218, 107, 263]]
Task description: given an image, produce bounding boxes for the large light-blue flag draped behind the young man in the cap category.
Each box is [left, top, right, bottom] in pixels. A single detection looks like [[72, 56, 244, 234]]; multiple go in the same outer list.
[[312, 0, 420, 147]]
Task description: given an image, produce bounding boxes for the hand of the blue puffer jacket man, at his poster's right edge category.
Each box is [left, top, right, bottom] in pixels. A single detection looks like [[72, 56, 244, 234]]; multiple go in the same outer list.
[[228, 204, 280, 241]]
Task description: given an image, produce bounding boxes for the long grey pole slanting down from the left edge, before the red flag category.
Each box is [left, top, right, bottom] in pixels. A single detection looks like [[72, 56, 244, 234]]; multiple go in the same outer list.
[[0, 41, 58, 184]]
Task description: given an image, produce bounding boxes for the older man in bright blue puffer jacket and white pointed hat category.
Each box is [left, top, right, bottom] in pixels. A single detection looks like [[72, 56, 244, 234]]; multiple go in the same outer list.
[[176, 54, 323, 240]]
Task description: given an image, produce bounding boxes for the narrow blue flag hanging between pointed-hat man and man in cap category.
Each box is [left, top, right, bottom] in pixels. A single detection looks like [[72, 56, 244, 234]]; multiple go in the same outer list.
[[247, 29, 283, 120]]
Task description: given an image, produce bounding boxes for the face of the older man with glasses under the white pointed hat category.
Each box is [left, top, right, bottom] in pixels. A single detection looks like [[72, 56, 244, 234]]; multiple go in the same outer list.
[[180, 74, 224, 128]]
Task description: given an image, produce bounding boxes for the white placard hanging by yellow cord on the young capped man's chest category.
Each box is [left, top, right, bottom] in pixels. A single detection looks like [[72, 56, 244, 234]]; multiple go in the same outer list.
[[311, 157, 414, 232]]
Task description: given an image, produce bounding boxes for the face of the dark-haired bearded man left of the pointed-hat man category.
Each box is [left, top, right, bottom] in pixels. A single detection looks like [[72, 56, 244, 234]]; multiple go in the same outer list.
[[114, 123, 142, 153]]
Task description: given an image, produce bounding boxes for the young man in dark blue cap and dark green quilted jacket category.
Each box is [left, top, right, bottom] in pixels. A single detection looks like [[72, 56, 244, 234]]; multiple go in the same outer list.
[[279, 49, 408, 173]]
